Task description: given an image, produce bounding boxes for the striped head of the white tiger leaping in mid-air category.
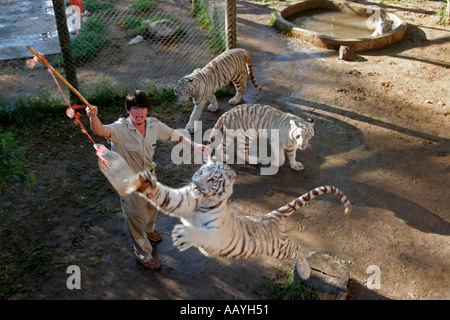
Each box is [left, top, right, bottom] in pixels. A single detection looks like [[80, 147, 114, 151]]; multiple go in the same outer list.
[[191, 157, 236, 200]]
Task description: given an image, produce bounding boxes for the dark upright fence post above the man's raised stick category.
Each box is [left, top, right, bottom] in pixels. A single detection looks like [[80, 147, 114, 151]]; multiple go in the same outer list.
[[52, 0, 81, 104]]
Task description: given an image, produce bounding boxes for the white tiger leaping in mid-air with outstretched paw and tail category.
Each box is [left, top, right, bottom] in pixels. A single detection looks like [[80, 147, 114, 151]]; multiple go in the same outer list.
[[134, 158, 352, 279]]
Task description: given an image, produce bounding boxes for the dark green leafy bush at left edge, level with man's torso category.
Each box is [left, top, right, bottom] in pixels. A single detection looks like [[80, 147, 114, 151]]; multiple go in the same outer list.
[[0, 132, 34, 191]]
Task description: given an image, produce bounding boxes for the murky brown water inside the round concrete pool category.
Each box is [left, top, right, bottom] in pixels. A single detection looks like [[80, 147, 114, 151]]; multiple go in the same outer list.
[[286, 9, 373, 38]]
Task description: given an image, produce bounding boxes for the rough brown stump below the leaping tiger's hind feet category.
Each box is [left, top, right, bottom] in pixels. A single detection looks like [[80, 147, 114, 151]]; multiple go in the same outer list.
[[293, 252, 350, 300]]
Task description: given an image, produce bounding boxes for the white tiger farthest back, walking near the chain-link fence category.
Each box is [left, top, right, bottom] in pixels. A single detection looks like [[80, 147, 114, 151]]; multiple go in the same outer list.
[[175, 49, 268, 133]]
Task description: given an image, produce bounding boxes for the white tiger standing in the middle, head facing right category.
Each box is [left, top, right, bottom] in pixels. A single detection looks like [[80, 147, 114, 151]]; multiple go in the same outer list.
[[208, 104, 314, 173]]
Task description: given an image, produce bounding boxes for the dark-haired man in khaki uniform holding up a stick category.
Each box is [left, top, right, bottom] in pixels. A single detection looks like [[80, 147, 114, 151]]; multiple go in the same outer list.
[[86, 90, 211, 270]]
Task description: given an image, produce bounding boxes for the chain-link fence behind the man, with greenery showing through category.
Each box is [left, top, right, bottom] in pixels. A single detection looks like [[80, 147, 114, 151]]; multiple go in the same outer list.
[[0, 0, 236, 96]]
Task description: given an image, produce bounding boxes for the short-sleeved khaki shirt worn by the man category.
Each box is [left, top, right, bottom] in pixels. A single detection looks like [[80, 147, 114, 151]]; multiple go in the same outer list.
[[108, 117, 172, 172]]
